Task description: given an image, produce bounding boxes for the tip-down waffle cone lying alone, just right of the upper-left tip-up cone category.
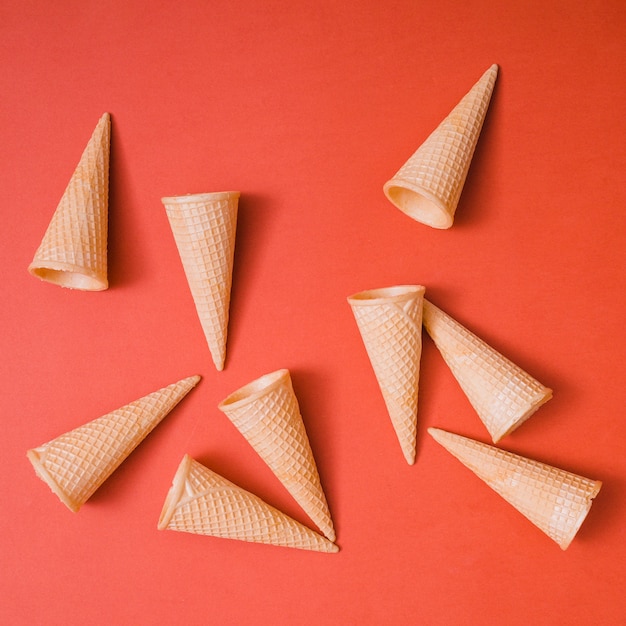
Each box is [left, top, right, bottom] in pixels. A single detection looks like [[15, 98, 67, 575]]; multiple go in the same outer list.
[[162, 191, 239, 371]]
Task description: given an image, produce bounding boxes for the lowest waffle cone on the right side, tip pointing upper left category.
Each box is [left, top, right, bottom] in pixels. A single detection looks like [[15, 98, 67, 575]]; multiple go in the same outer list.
[[428, 428, 602, 550]]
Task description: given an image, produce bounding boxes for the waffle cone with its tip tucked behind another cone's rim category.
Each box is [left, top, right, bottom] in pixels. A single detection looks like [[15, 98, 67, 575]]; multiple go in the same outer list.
[[423, 300, 552, 443]]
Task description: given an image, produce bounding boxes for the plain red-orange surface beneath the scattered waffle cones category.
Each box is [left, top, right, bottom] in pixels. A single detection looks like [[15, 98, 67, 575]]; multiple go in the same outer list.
[[0, 0, 626, 626]]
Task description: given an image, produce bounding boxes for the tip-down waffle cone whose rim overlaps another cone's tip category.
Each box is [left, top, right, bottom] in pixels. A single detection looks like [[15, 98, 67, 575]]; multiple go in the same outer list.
[[348, 285, 425, 465]]
